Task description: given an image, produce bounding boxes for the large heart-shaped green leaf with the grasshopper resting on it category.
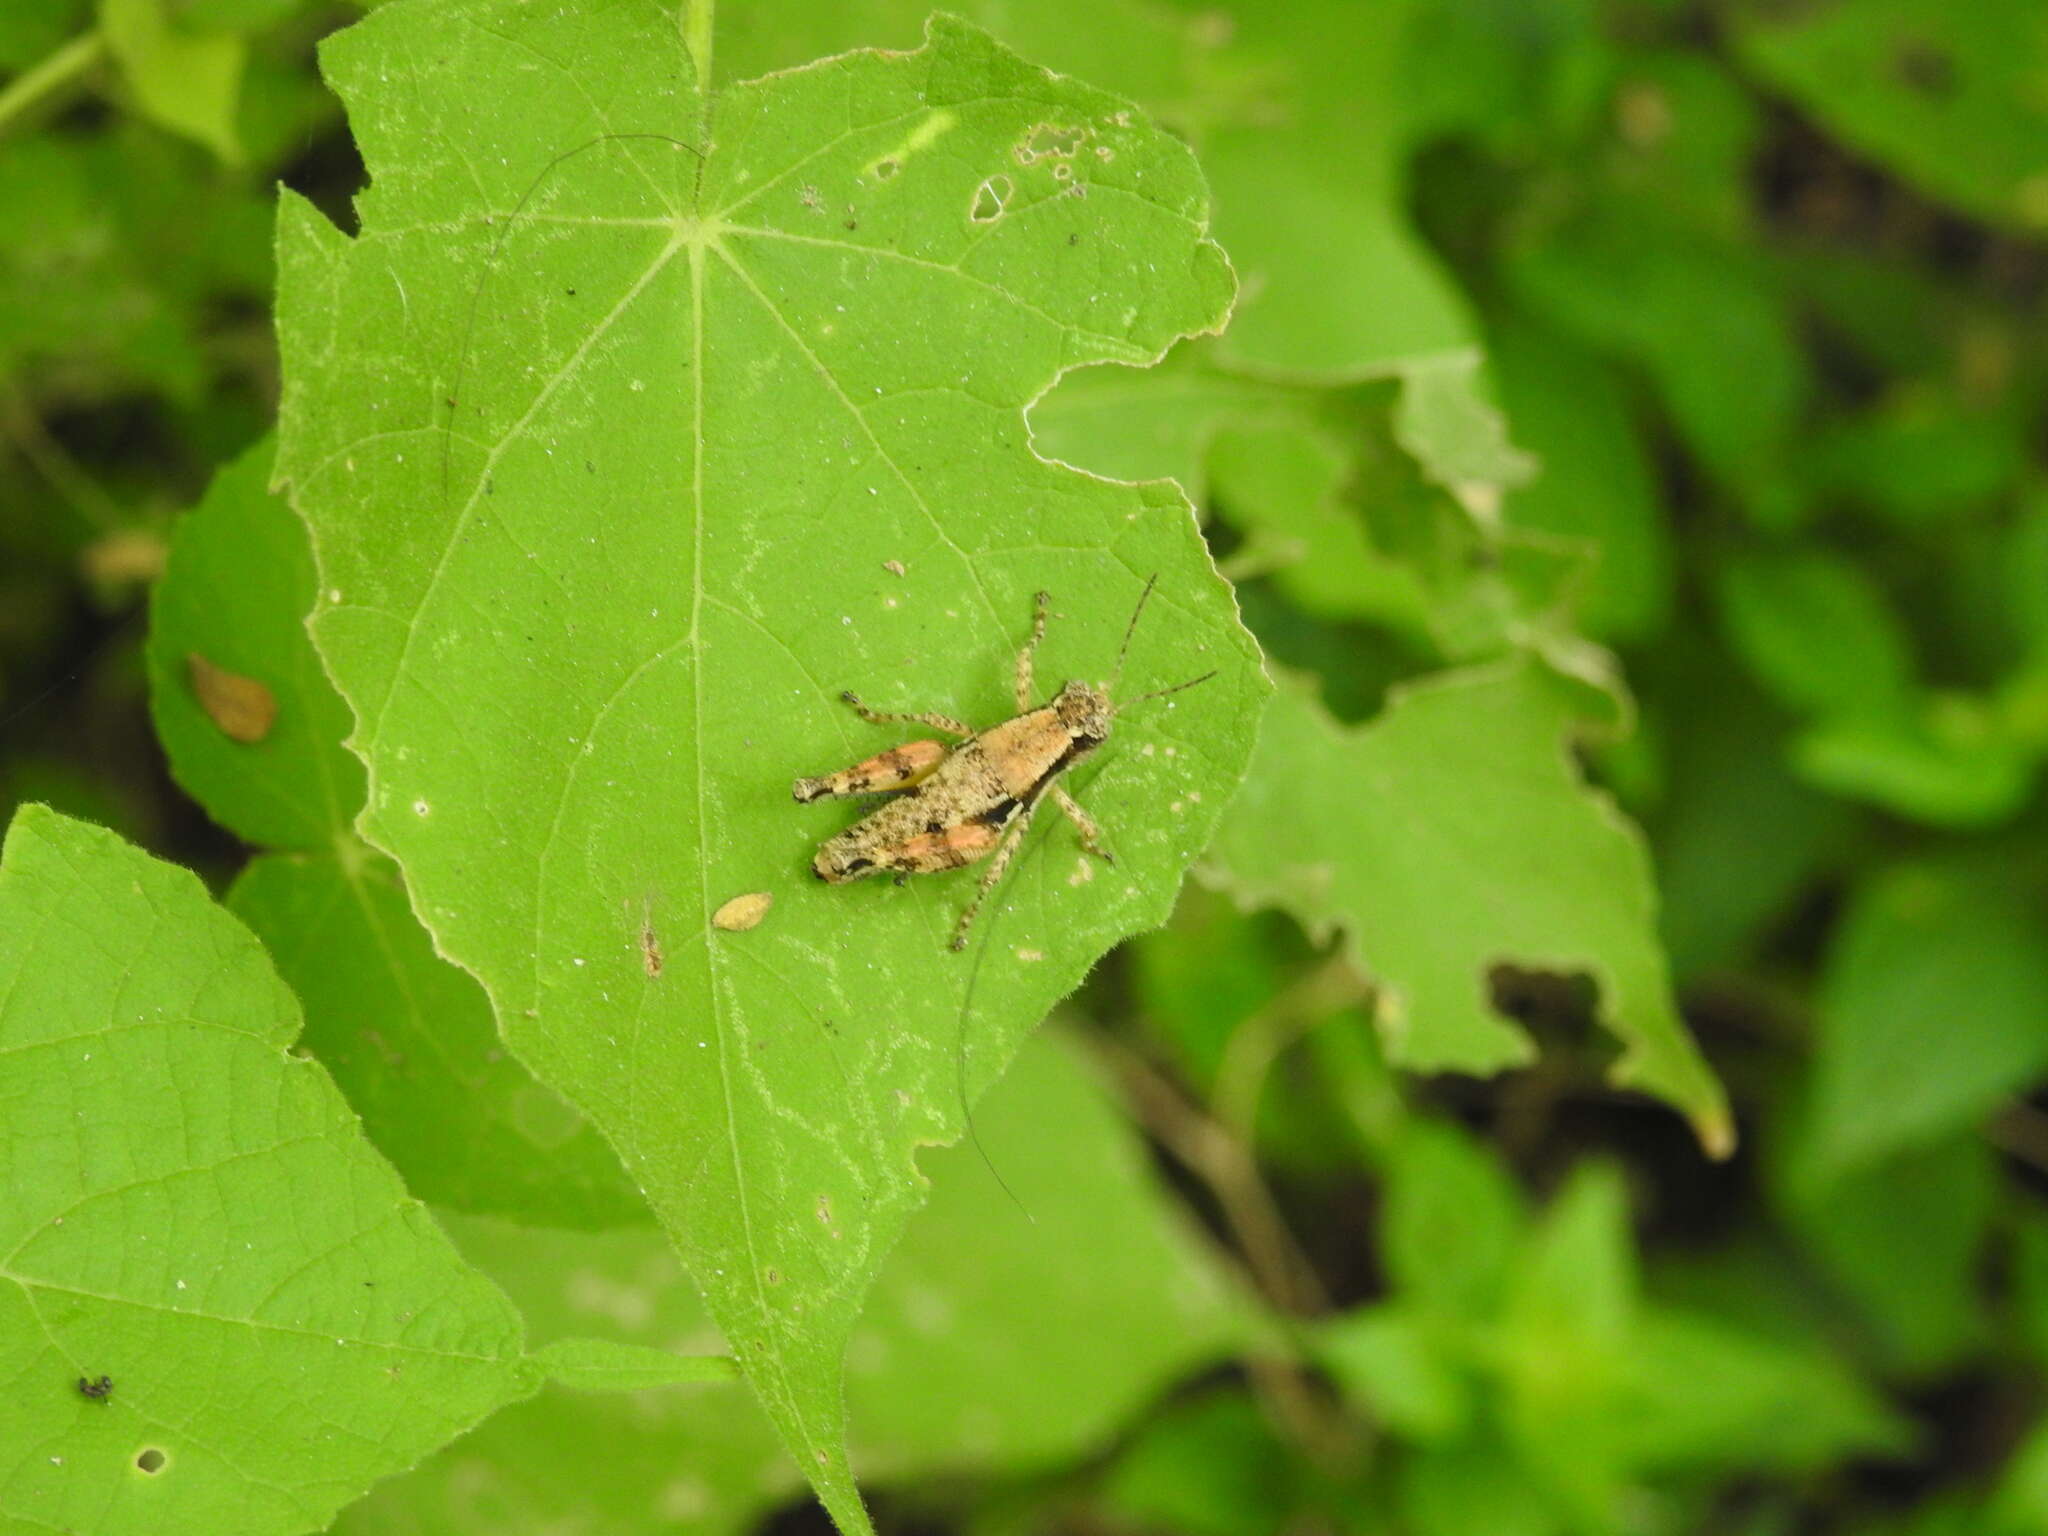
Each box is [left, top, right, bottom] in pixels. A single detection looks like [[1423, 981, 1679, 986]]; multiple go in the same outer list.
[[279, 0, 1266, 1528]]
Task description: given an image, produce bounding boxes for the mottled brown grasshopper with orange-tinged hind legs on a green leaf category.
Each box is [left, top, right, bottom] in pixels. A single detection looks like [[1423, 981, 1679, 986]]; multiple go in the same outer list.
[[791, 575, 1217, 950]]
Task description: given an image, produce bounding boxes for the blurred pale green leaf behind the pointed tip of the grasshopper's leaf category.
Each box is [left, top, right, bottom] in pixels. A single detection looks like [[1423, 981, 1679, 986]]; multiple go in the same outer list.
[[336, 1032, 1251, 1536]]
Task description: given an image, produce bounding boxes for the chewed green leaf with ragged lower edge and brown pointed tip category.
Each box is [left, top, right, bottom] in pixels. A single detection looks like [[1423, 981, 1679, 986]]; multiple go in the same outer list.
[[1212, 662, 1733, 1149]]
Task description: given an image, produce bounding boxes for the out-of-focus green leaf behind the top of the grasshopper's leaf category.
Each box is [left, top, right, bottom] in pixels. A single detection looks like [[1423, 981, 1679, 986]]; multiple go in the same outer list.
[[721, 0, 1477, 381]]
